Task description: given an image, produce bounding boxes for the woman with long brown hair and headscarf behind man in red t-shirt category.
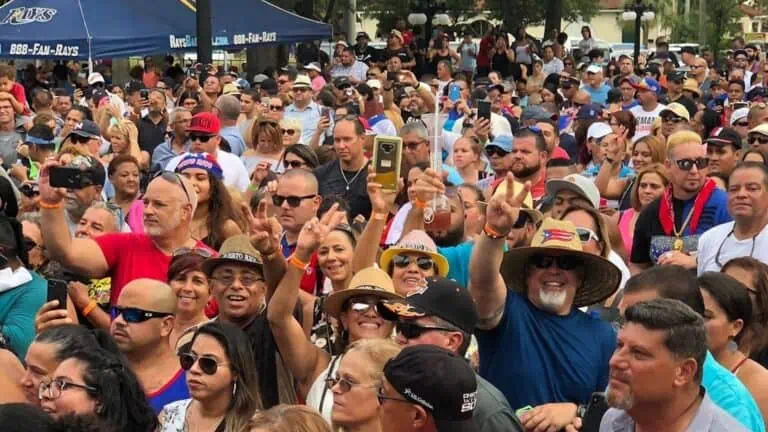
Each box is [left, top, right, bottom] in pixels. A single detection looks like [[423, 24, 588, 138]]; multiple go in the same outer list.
[[176, 153, 246, 250]]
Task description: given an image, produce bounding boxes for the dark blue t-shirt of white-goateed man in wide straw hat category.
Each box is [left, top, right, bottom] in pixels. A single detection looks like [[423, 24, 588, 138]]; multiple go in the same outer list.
[[475, 291, 616, 410]]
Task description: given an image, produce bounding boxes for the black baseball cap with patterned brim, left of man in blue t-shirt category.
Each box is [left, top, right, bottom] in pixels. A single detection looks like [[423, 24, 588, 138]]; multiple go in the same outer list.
[[382, 276, 478, 334]]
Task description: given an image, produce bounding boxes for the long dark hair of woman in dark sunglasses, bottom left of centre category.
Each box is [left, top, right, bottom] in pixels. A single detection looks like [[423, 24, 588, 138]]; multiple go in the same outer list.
[[189, 321, 263, 432]]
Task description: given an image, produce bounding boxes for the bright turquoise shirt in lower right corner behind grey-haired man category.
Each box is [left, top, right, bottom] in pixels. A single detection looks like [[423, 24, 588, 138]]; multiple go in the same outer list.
[[701, 351, 765, 432]]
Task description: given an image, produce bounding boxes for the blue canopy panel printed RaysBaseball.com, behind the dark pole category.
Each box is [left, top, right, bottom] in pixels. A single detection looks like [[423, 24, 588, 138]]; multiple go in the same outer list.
[[165, 0, 333, 50]]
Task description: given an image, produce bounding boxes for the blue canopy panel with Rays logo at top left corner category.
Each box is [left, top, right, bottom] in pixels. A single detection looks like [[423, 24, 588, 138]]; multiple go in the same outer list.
[[0, 0, 189, 62]]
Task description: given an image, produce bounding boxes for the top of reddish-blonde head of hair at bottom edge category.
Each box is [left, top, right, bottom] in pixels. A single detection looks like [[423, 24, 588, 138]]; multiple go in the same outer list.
[[248, 404, 331, 432]]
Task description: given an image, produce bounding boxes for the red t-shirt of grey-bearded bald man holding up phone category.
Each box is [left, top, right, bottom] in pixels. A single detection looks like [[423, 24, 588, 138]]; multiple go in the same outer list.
[[93, 233, 215, 304]]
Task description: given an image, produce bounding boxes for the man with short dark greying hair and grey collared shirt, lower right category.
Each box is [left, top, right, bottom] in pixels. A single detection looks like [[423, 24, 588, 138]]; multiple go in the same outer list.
[[600, 299, 747, 432]]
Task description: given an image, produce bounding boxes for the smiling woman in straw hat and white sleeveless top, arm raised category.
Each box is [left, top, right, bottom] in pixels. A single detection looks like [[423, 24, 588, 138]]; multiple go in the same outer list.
[[267, 205, 402, 419]]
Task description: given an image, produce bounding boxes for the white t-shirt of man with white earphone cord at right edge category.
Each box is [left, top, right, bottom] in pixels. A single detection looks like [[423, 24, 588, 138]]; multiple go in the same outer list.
[[696, 222, 768, 275]]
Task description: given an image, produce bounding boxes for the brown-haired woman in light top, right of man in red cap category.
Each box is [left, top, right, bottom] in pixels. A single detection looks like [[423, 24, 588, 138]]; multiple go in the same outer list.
[[241, 118, 283, 174]]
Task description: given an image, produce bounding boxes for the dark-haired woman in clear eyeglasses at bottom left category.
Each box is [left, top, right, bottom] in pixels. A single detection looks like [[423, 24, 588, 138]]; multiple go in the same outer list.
[[38, 338, 157, 432]]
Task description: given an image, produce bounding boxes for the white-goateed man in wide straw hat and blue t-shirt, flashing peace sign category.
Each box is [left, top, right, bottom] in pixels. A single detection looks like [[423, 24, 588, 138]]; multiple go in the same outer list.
[[469, 173, 621, 430]]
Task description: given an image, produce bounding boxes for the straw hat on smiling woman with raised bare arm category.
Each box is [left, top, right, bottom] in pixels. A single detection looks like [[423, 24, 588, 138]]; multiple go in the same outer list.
[[323, 267, 403, 318]]
